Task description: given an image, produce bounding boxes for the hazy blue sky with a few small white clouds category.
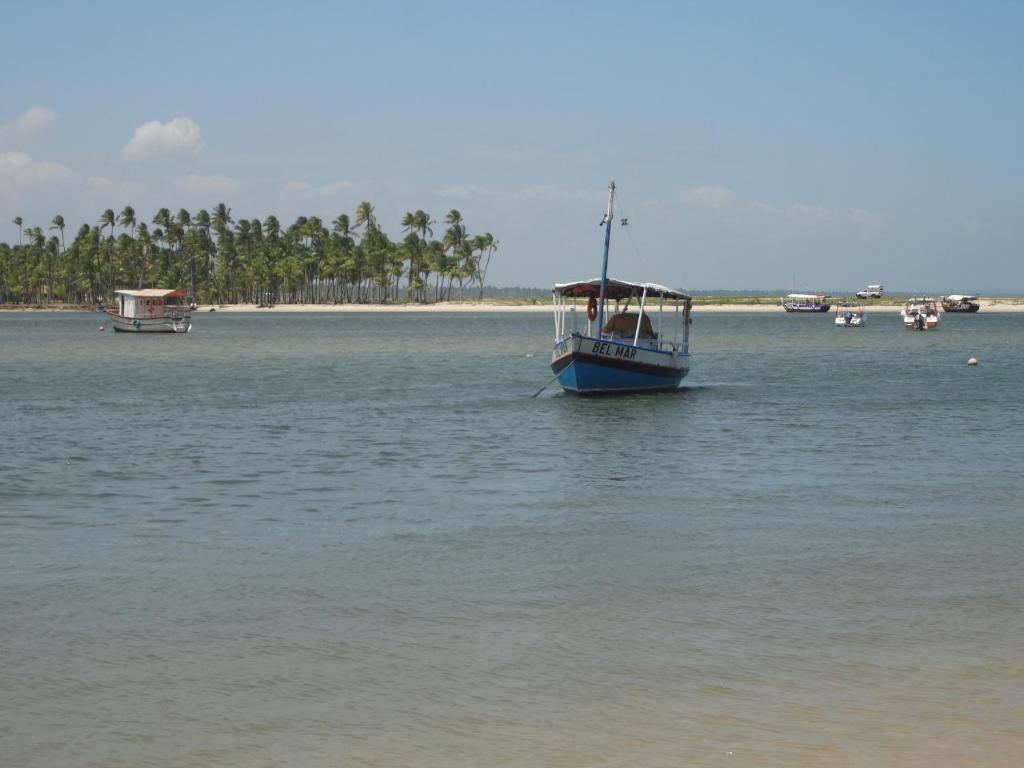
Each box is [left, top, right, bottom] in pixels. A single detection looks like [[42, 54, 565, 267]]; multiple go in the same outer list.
[[0, 0, 1024, 295]]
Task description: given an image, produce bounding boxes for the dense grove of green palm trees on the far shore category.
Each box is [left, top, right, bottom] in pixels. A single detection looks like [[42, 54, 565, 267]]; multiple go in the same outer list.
[[0, 202, 498, 305]]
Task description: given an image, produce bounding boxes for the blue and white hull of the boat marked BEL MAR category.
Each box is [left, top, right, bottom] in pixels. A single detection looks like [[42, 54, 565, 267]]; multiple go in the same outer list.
[[551, 336, 689, 395]]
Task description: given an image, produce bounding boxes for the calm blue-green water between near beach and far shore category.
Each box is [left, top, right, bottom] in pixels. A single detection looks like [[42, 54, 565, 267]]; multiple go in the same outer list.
[[6, 312, 1024, 768]]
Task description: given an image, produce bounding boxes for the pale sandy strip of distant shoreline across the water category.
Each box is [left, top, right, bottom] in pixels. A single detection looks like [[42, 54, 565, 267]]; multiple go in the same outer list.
[[0, 296, 1024, 314]]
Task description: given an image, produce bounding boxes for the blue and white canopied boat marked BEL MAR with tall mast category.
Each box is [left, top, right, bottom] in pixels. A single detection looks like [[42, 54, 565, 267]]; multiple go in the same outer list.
[[551, 181, 692, 395]]
